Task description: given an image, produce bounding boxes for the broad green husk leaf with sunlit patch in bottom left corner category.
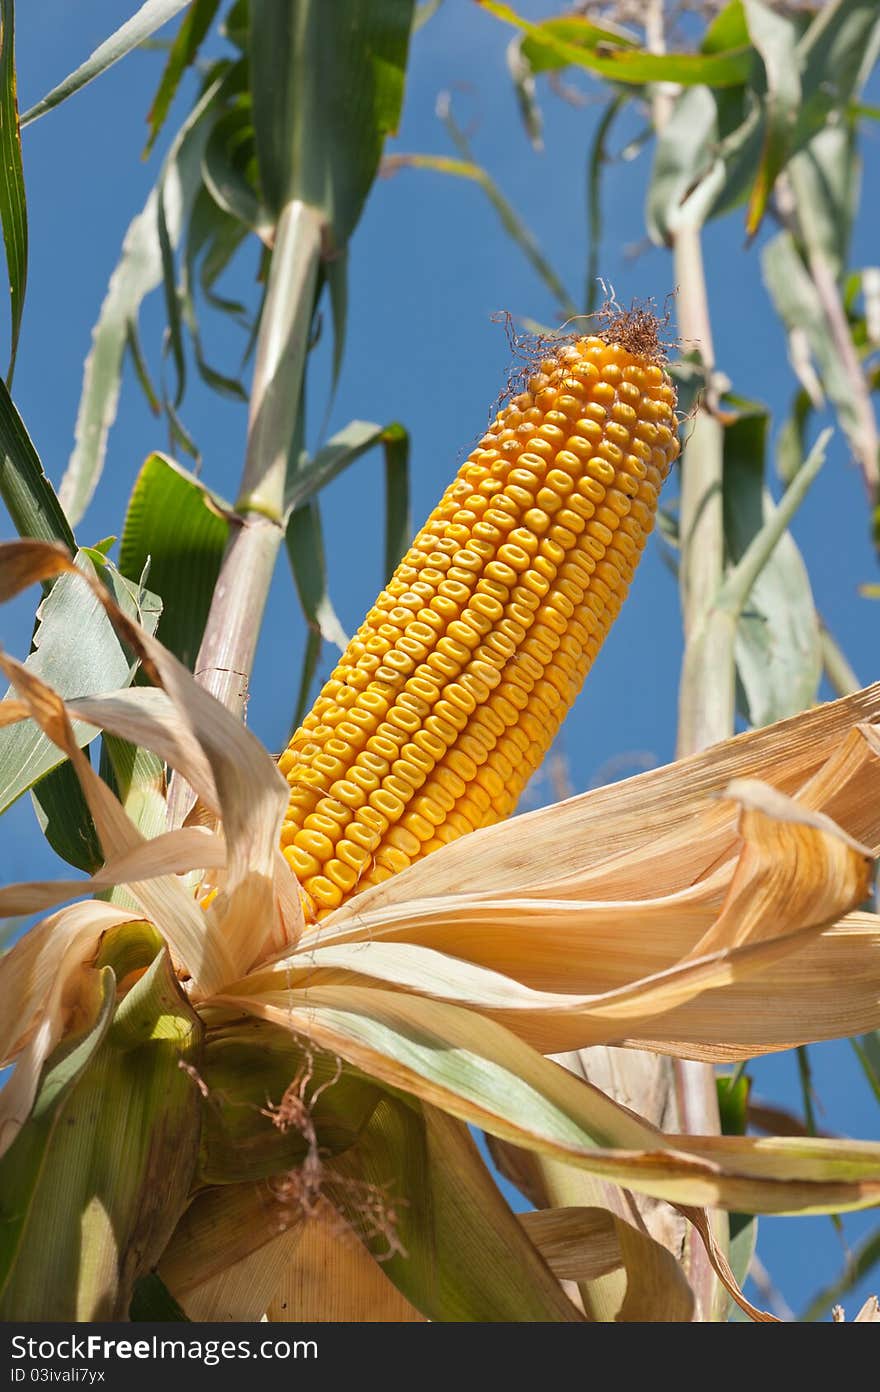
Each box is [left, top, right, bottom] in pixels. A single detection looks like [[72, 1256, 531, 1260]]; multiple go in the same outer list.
[[0, 924, 202, 1320]]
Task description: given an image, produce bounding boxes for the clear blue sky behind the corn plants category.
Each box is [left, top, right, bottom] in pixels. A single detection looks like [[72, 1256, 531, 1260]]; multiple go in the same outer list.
[[0, 0, 880, 1310]]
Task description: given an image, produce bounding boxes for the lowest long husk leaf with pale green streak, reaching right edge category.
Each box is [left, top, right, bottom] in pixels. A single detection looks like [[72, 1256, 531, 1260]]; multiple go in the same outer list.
[[217, 986, 880, 1212]]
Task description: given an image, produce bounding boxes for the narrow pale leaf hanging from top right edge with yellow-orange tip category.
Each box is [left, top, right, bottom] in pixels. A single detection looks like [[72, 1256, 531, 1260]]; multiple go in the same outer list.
[[745, 0, 801, 237]]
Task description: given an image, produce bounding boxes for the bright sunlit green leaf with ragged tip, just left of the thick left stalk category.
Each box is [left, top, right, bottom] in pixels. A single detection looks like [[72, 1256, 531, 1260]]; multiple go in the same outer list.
[[120, 454, 230, 670]]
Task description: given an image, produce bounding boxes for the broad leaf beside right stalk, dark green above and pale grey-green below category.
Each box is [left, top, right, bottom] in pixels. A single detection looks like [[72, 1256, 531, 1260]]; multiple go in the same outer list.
[[724, 404, 822, 725]]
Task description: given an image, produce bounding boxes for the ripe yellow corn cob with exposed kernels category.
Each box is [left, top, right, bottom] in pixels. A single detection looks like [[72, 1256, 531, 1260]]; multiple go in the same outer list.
[[280, 324, 678, 915]]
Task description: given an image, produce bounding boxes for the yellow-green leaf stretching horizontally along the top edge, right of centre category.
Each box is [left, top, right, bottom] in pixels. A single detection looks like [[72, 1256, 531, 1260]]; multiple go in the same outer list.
[[478, 0, 753, 86]]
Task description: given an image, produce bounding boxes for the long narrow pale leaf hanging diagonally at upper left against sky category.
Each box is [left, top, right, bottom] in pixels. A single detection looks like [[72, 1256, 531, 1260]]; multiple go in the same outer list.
[[60, 82, 220, 526]]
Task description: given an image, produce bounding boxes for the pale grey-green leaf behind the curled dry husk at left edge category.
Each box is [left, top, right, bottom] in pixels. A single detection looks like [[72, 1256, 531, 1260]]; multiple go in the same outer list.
[[0, 551, 160, 812]]
